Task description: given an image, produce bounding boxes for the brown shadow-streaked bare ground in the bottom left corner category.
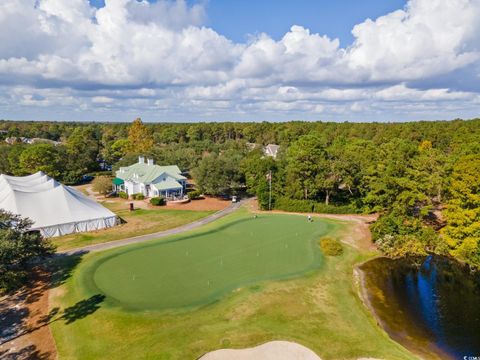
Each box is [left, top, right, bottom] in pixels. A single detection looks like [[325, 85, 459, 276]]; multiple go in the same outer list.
[[0, 271, 56, 360]]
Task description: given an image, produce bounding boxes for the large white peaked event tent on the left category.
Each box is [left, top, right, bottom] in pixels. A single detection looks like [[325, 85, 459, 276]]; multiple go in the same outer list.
[[0, 172, 118, 237]]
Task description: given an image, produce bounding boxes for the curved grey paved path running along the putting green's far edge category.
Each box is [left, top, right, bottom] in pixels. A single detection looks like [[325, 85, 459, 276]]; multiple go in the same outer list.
[[61, 200, 246, 255]]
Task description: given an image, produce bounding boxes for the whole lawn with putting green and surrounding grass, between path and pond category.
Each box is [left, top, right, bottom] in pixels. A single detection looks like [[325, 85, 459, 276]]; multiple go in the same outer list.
[[51, 210, 413, 360]]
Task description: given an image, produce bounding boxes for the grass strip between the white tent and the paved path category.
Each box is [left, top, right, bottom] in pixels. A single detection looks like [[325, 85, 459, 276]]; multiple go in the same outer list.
[[52, 202, 215, 250]]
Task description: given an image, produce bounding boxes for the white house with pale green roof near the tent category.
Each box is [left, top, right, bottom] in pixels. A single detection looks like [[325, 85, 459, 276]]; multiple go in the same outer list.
[[112, 156, 187, 199]]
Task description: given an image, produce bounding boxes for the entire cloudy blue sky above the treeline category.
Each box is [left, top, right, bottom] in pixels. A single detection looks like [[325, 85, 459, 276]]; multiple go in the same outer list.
[[0, 0, 480, 122]]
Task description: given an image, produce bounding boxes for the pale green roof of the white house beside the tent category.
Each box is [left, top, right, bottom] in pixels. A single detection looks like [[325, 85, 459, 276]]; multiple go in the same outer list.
[[116, 163, 186, 184]]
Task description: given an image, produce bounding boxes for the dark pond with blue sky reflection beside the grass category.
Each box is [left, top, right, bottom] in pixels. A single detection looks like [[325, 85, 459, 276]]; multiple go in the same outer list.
[[360, 256, 480, 359]]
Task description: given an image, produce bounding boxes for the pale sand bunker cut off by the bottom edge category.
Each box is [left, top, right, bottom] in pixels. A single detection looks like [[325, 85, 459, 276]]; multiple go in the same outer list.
[[200, 341, 321, 360]]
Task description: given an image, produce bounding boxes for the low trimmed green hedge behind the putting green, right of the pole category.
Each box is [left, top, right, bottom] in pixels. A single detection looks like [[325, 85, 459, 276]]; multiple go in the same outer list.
[[275, 198, 359, 214]]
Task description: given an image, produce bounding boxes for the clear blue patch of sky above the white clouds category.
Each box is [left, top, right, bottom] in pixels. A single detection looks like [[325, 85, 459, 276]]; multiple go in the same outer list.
[[90, 0, 406, 46]]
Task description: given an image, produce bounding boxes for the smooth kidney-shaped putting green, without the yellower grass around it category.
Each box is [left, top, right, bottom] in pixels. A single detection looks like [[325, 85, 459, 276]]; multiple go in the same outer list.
[[89, 212, 340, 310]]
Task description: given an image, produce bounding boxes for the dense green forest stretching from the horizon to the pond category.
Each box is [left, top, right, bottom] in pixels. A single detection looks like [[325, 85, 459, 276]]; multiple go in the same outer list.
[[0, 119, 480, 265]]
